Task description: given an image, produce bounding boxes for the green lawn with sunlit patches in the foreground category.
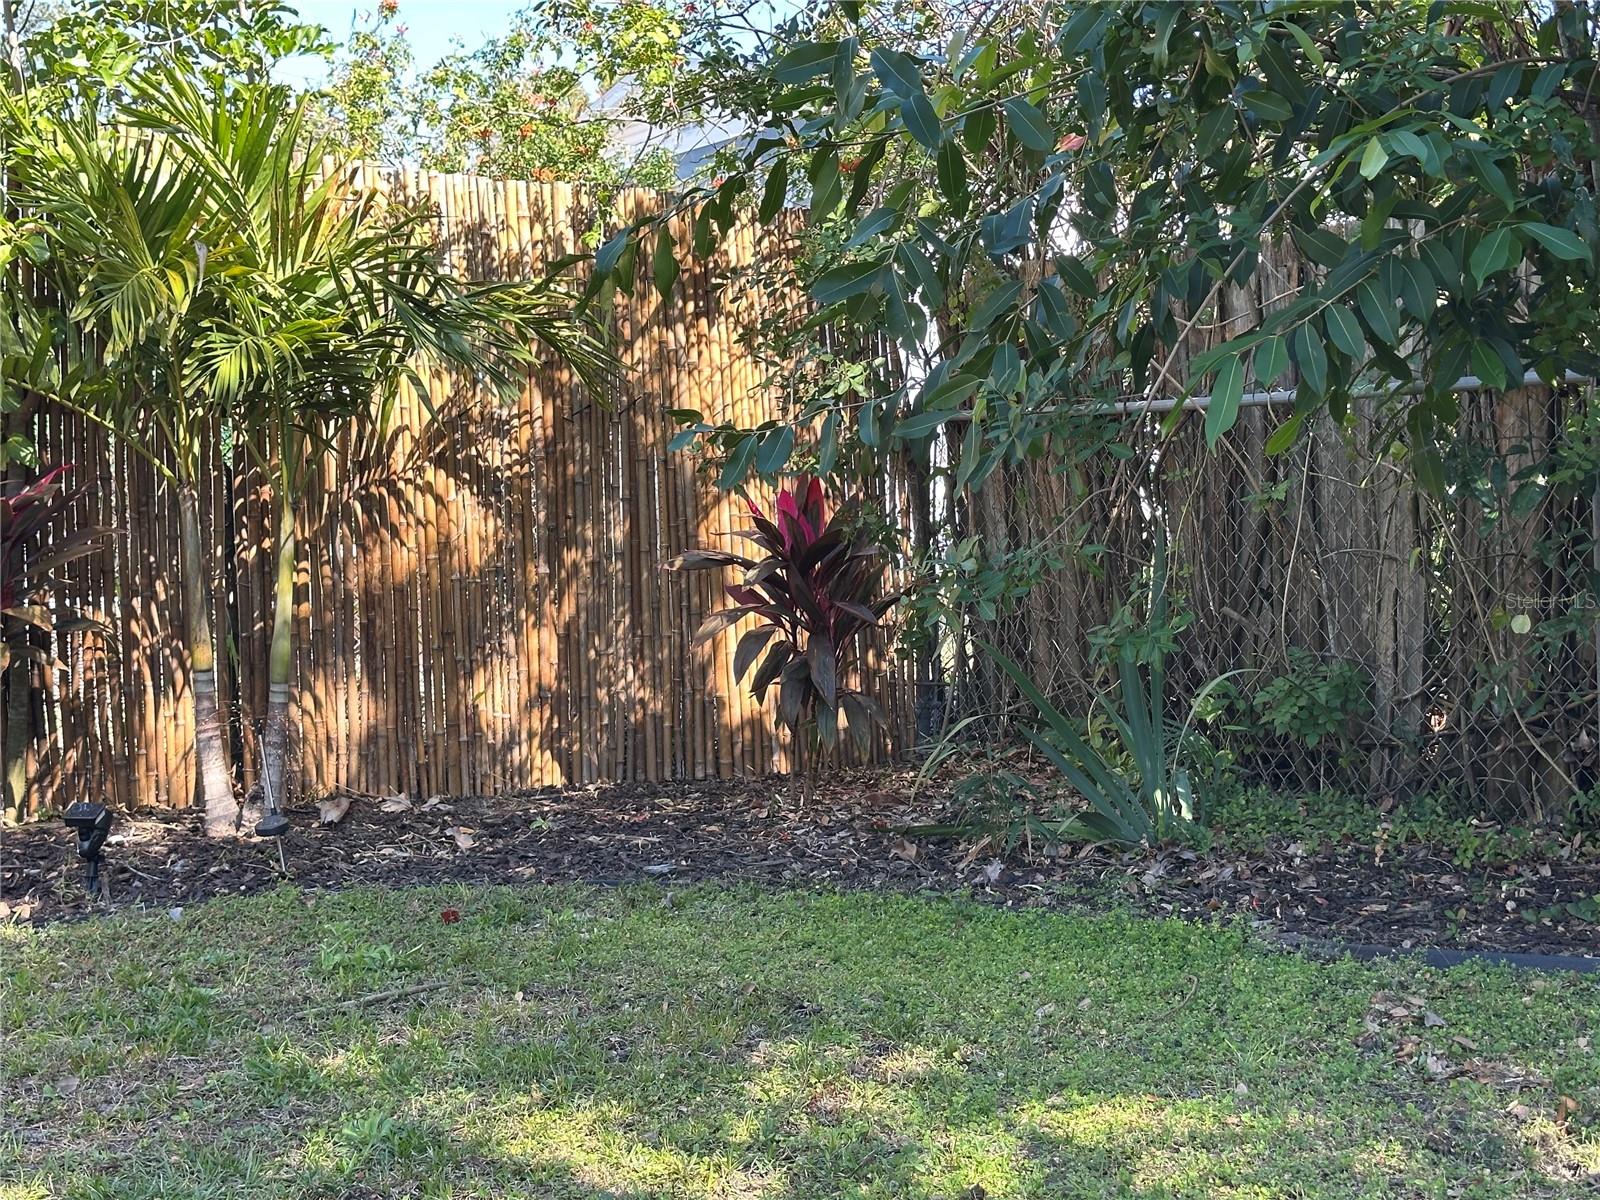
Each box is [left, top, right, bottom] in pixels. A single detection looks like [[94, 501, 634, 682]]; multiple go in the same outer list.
[[0, 886, 1600, 1200]]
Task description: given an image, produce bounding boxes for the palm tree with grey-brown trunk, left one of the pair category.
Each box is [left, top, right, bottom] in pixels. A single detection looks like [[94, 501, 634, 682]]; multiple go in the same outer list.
[[5, 98, 238, 832]]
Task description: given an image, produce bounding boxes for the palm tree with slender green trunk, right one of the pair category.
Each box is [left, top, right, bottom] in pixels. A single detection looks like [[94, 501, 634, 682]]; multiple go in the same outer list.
[[130, 75, 610, 825]]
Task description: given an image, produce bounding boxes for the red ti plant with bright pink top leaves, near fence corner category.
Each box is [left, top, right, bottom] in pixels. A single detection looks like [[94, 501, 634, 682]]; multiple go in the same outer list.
[[667, 475, 901, 774]]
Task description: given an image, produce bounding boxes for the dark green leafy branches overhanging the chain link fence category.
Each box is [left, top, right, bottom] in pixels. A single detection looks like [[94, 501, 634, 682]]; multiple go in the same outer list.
[[588, 3, 1597, 488]]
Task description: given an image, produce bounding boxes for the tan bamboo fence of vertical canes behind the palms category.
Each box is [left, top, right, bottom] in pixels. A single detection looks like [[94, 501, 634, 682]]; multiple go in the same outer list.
[[6, 173, 910, 811]]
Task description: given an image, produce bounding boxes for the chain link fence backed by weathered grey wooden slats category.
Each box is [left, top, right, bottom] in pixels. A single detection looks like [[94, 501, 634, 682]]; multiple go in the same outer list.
[[923, 386, 1600, 821]]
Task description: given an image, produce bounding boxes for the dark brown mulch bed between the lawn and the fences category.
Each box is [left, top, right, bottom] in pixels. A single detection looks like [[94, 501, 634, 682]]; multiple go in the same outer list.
[[0, 773, 1600, 954]]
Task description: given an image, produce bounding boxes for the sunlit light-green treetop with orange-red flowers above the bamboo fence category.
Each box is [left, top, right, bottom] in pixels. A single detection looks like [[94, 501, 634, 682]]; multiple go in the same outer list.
[[318, 0, 758, 189]]
